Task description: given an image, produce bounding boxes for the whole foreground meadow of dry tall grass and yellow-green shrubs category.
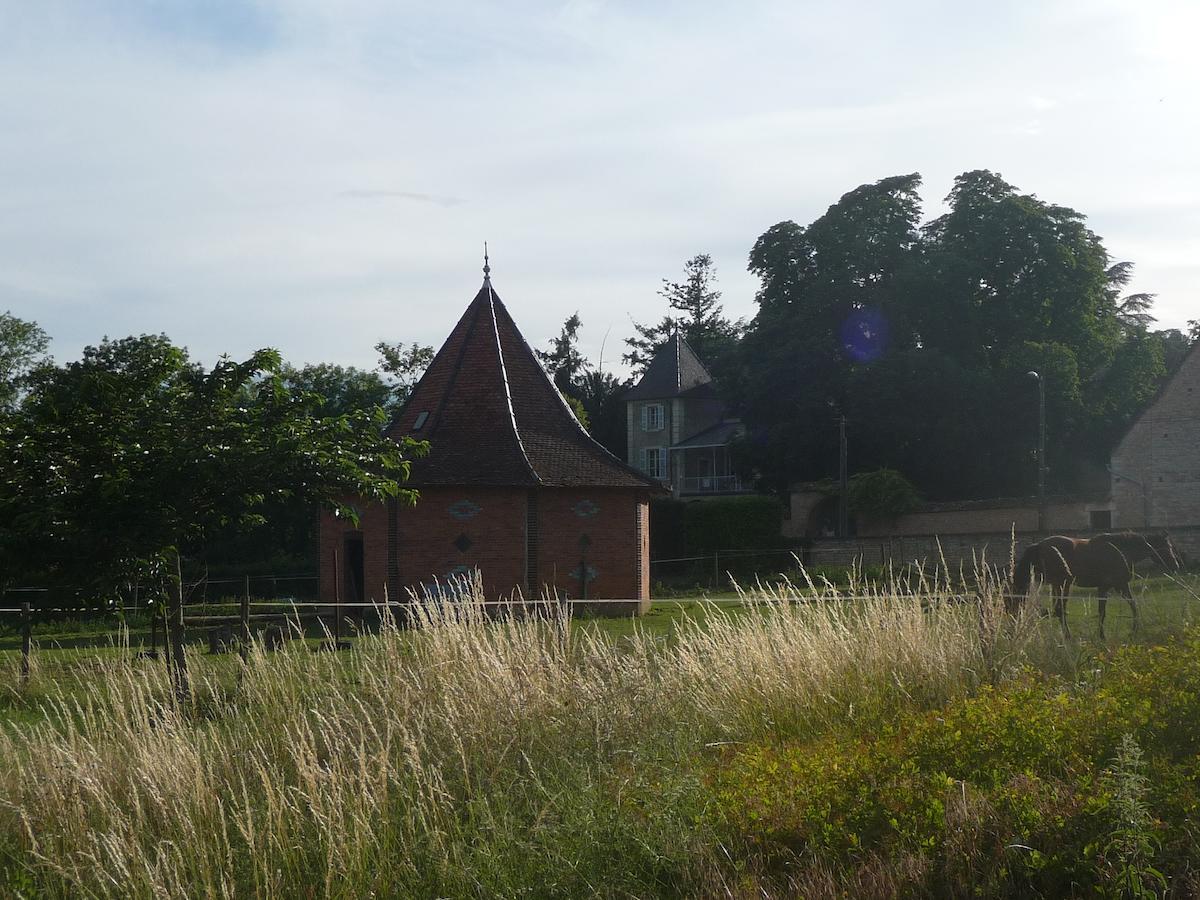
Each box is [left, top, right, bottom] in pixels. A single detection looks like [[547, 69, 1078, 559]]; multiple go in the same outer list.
[[0, 577, 1200, 898]]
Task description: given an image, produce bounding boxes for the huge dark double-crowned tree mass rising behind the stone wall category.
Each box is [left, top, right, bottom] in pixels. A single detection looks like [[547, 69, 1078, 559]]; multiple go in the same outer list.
[[742, 170, 1164, 498]]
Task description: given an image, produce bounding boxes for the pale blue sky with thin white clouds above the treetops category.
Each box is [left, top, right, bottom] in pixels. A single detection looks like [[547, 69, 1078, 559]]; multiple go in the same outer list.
[[0, 0, 1200, 370]]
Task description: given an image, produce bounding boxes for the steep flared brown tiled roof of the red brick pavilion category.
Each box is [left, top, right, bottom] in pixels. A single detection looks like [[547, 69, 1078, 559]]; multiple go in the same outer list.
[[388, 278, 661, 491]]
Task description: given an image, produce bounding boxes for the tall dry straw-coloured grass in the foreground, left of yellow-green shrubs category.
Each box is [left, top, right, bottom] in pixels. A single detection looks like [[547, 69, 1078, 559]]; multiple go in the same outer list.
[[0, 573, 1056, 898]]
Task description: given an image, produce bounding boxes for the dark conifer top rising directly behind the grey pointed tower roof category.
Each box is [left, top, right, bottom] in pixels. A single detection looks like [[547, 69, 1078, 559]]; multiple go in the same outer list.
[[623, 253, 745, 382]]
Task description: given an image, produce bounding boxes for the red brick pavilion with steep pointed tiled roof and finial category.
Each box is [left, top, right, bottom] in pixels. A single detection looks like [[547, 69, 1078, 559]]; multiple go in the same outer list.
[[319, 265, 662, 611]]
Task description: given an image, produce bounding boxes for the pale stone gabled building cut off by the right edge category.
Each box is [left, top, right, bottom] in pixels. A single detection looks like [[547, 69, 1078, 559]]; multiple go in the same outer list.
[[1109, 343, 1200, 529]]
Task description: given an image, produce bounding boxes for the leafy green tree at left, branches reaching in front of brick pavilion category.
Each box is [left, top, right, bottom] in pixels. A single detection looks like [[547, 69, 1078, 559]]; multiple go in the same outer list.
[[0, 335, 424, 595]]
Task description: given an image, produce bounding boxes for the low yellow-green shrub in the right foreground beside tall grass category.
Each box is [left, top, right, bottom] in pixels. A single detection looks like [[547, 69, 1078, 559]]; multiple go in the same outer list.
[[709, 635, 1200, 895]]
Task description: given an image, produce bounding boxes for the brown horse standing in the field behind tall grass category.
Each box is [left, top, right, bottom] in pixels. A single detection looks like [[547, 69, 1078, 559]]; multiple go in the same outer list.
[[1013, 532, 1182, 638]]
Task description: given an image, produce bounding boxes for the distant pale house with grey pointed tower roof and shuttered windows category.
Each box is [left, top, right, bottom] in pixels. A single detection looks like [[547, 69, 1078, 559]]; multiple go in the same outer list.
[[625, 331, 744, 497]]
